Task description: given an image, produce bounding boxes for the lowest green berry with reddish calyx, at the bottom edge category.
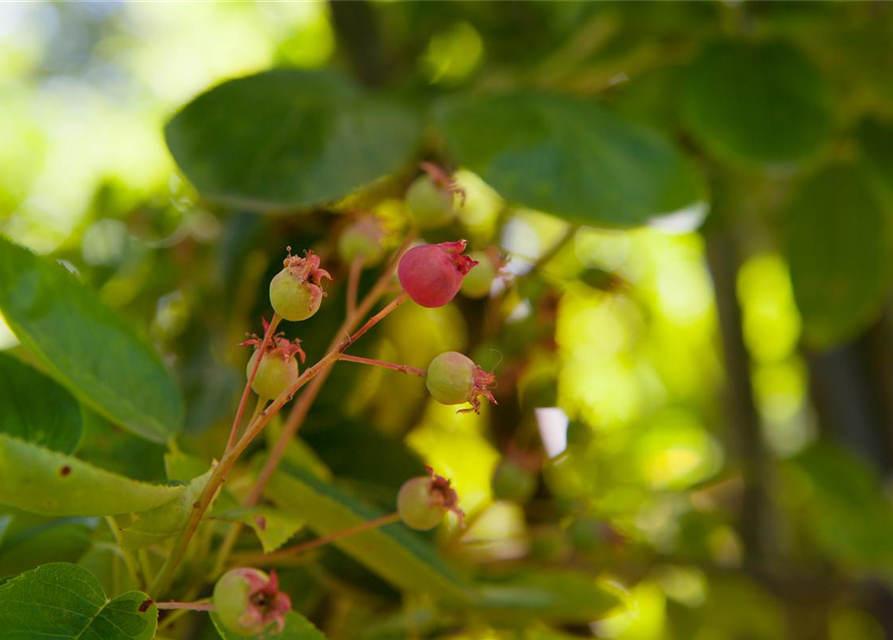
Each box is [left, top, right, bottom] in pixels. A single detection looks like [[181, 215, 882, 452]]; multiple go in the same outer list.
[[214, 568, 291, 636]]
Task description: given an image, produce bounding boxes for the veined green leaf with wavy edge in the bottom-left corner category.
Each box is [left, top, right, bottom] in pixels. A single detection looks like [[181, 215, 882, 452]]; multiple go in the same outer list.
[[0, 562, 158, 640]]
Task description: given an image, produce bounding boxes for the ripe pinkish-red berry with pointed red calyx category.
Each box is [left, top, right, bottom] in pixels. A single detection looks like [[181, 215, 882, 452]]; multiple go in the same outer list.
[[397, 240, 477, 308]]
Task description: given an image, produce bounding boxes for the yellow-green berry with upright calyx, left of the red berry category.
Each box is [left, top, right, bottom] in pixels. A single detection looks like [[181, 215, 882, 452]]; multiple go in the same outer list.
[[270, 247, 332, 322]]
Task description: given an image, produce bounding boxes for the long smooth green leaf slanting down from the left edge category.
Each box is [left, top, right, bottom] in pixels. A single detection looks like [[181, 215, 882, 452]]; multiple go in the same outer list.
[[0, 237, 181, 442]]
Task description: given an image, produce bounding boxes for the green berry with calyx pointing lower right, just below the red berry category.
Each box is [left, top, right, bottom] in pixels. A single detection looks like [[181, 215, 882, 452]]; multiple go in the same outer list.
[[425, 351, 497, 413]]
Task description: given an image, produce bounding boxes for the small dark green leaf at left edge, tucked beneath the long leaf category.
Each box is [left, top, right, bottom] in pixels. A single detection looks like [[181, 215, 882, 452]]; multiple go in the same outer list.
[[0, 353, 81, 453]]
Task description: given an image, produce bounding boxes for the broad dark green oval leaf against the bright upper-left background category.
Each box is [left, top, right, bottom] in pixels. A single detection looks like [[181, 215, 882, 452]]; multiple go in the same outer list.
[[165, 69, 421, 210]]
